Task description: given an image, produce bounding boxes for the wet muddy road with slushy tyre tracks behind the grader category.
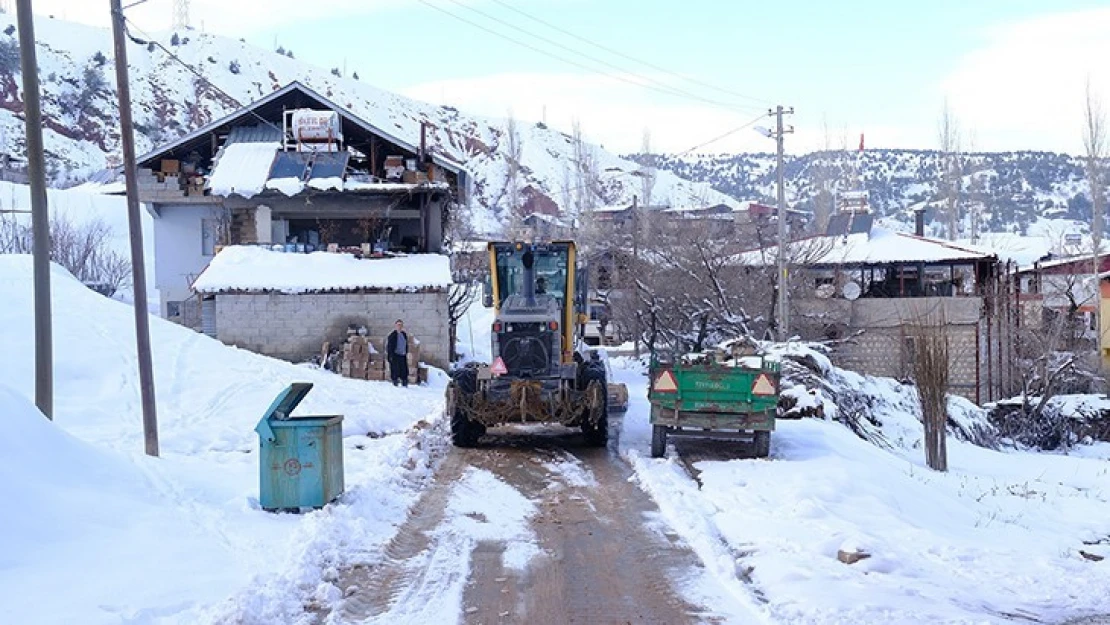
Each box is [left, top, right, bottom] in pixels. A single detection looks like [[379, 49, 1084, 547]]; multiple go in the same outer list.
[[323, 423, 745, 625]]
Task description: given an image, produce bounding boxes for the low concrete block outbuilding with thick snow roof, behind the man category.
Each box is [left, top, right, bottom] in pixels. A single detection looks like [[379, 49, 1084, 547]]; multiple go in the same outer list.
[[193, 246, 452, 369]]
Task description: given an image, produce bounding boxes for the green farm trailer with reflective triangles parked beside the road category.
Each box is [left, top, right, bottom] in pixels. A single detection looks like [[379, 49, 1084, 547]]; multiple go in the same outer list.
[[648, 354, 781, 457]]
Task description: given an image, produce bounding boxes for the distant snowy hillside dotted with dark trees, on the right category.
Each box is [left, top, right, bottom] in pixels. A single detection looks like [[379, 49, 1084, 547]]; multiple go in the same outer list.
[[629, 150, 1091, 236]]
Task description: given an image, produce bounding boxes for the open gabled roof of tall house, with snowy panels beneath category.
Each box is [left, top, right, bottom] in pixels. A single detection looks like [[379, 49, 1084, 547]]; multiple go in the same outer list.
[[139, 81, 468, 198]]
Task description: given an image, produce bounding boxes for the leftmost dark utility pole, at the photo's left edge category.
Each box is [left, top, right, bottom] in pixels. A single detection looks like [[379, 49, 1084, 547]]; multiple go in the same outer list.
[[16, 0, 54, 420]]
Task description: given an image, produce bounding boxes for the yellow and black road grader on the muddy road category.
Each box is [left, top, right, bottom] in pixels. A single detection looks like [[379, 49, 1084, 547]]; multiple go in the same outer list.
[[447, 241, 608, 446]]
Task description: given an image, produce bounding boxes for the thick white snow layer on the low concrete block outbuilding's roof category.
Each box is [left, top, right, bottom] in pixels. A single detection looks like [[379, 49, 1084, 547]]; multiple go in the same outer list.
[[193, 245, 452, 294]]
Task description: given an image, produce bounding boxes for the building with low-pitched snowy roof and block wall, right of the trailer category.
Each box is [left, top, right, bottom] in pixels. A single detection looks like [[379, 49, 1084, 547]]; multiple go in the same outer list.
[[740, 226, 1017, 403]]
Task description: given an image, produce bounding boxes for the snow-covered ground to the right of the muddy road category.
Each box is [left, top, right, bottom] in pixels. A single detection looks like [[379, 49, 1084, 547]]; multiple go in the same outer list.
[[611, 359, 1110, 624]]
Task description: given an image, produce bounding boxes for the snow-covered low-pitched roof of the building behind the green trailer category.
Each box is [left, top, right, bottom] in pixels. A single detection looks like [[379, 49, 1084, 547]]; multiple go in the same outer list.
[[737, 226, 996, 266]]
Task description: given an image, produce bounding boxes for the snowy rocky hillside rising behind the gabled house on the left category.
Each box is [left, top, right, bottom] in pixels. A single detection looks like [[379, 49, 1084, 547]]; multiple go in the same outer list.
[[0, 14, 731, 231]]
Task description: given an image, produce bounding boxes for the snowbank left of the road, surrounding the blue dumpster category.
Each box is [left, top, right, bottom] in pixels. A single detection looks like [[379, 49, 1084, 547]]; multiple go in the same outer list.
[[0, 255, 444, 625]]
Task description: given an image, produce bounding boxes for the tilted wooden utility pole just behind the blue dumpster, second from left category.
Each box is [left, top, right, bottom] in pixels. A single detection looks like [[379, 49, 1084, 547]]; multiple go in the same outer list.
[[109, 0, 158, 456]]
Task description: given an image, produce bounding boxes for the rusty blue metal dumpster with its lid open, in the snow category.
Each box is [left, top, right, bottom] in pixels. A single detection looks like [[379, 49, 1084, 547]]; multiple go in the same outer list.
[[254, 382, 343, 512]]
